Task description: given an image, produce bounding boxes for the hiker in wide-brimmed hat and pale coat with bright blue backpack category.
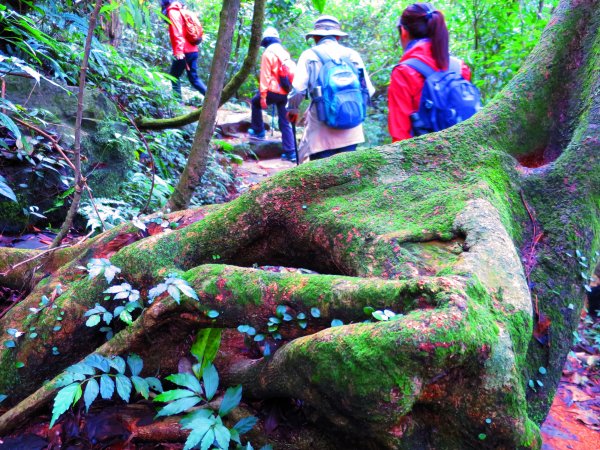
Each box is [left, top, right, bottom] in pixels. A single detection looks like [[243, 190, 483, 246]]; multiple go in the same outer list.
[[288, 16, 375, 162]]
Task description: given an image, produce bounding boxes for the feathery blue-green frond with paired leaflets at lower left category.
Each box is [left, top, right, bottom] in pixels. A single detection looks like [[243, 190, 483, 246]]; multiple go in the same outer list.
[[50, 354, 162, 427]]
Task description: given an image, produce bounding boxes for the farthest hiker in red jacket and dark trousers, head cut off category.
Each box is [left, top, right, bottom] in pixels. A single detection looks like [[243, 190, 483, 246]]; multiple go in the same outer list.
[[161, 0, 206, 100]]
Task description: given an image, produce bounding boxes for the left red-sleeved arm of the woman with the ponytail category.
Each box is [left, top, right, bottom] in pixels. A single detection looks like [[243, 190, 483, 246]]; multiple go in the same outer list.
[[388, 66, 419, 142]]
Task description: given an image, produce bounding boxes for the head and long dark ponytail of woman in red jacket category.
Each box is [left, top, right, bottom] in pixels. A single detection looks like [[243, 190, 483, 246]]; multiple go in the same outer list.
[[399, 3, 450, 70]]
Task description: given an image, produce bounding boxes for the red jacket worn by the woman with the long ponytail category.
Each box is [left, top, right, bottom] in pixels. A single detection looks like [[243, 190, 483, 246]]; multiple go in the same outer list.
[[388, 40, 471, 142]]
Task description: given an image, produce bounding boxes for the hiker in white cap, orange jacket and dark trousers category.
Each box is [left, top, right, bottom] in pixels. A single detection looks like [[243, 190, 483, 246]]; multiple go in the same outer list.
[[248, 27, 296, 162]]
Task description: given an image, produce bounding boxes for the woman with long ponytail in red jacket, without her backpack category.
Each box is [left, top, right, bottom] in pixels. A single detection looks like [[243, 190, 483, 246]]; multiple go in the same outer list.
[[388, 3, 479, 142]]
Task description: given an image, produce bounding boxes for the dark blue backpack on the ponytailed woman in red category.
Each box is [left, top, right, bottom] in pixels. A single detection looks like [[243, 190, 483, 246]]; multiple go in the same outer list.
[[400, 58, 481, 136]]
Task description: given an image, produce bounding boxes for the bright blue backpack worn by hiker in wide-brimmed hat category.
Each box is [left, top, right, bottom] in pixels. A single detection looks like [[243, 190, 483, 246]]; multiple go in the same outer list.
[[312, 47, 369, 130]]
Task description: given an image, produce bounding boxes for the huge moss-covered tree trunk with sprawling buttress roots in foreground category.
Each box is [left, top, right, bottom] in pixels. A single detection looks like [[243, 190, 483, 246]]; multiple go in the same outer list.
[[0, 0, 600, 449]]
